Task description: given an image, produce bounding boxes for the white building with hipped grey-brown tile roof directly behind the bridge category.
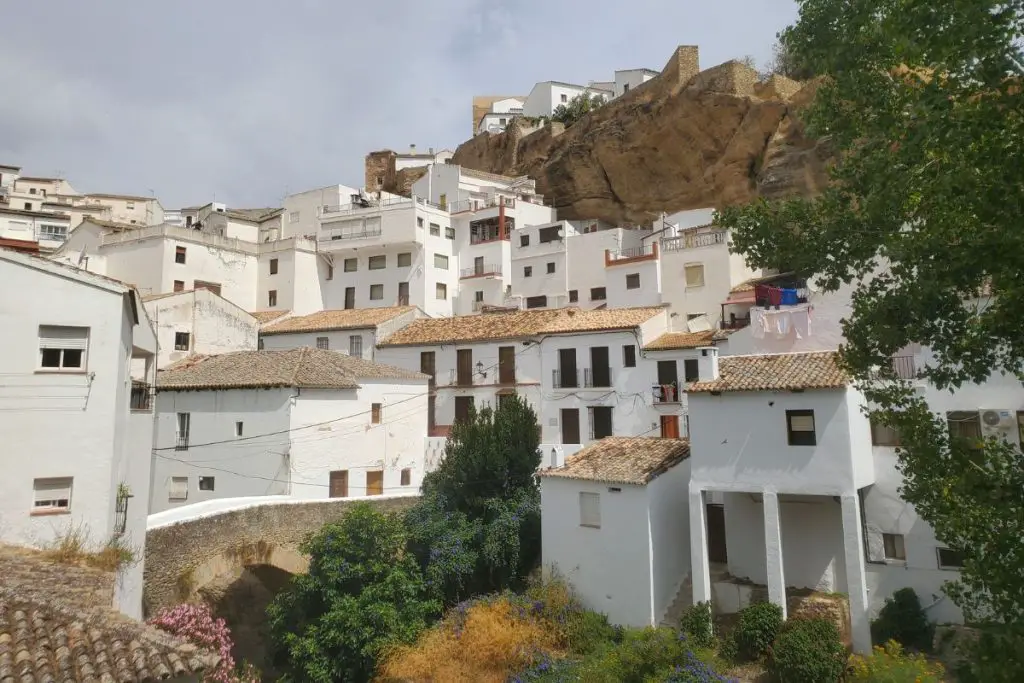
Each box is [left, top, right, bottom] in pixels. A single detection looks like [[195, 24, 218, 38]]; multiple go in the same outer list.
[[150, 348, 427, 512]]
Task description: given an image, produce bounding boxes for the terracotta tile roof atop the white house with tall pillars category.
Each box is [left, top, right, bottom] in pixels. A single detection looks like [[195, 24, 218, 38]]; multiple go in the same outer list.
[[686, 351, 850, 393]]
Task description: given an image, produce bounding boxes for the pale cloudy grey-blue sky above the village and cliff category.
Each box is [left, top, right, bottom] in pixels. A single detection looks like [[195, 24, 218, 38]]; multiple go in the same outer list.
[[0, 0, 797, 208]]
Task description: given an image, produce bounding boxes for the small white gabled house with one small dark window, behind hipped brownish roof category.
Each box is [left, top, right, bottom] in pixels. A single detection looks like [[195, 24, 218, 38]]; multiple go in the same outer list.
[[142, 289, 259, 369]]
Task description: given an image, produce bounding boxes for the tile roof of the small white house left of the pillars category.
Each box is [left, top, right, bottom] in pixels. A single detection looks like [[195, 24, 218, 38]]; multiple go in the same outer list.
[[541, 436, 690, 485]]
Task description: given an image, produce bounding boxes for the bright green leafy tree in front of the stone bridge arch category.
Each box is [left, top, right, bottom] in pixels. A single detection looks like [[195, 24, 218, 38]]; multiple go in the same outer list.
[[267, 503, 440, 683]]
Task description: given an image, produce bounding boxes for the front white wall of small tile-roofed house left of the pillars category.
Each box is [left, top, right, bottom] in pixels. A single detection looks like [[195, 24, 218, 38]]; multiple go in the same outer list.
[[541, 477, 653, 626]]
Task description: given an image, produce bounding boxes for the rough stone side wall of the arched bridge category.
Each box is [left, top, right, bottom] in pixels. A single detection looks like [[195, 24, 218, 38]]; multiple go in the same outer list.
[[144, 497, 417, 615]]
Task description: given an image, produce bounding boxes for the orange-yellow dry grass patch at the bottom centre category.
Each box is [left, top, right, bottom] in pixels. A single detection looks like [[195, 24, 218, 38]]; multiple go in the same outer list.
[[377, 598, 558, 683]]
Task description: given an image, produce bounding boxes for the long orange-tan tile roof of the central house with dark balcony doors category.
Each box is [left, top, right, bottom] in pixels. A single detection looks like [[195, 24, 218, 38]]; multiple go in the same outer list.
[[379, 307, 665, 346]]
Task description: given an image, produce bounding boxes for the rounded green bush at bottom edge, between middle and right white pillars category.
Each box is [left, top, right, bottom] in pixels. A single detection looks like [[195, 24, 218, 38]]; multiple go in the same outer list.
[[768, 618, 847, 683]]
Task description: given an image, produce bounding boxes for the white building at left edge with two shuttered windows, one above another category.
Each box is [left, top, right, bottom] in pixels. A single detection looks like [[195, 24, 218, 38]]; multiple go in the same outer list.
[[0, 250, 157, 618]]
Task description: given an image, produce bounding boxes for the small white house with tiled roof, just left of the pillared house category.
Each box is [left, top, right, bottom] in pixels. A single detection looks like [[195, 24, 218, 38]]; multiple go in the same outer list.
[[540, 436, 690, 627]]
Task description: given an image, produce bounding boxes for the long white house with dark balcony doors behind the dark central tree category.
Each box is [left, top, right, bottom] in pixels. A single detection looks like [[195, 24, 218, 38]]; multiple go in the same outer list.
[[375, 307, 669, 444]]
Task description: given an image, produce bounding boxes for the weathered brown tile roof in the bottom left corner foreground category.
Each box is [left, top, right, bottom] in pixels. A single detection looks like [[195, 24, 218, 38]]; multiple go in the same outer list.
[[0, 546, 218, 683]]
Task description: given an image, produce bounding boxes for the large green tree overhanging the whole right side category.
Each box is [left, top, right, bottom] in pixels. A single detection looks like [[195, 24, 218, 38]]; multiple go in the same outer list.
[[719, 0, 1024, 681]]
